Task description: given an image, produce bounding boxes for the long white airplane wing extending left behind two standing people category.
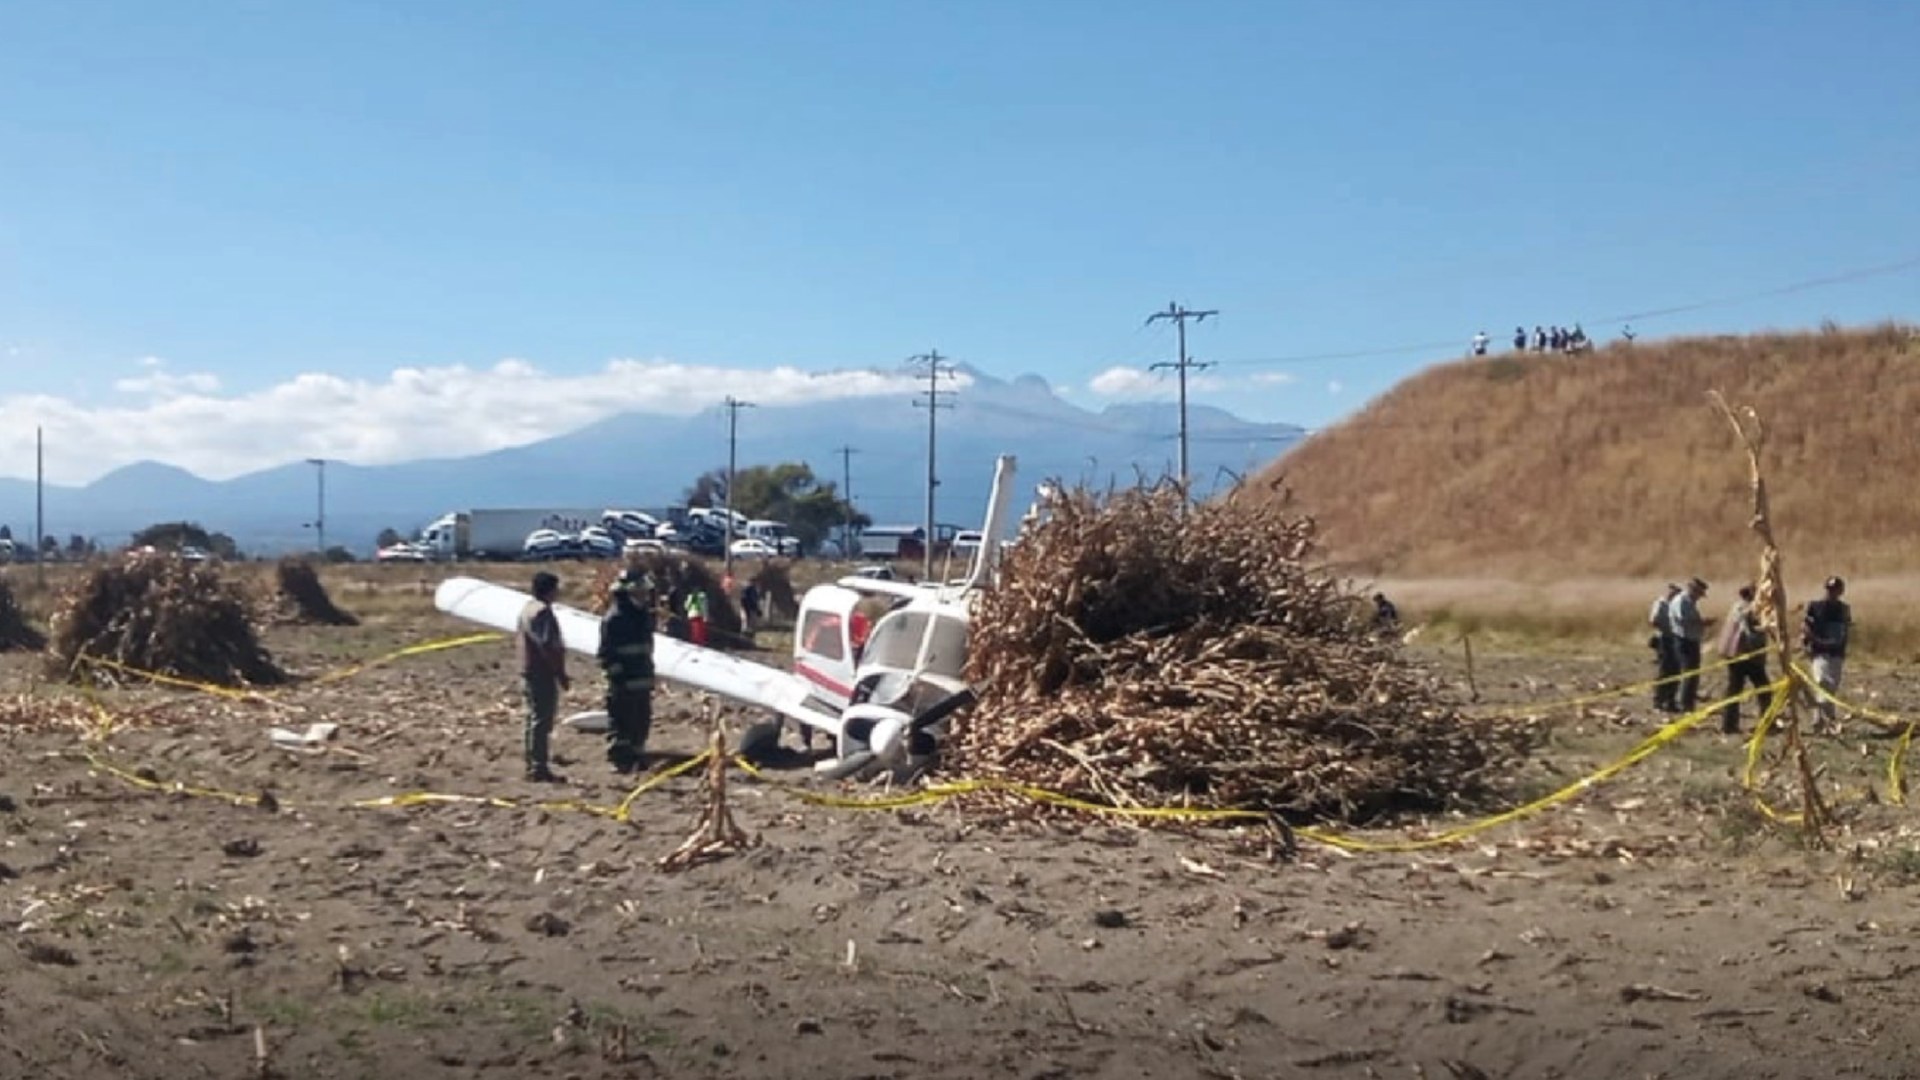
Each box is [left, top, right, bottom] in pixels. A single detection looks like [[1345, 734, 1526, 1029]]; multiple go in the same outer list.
[[434, 577, 841, 736]]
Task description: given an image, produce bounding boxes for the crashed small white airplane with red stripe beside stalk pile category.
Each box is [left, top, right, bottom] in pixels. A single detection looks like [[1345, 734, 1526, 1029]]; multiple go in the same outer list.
[[434, 455, 1014, 776]]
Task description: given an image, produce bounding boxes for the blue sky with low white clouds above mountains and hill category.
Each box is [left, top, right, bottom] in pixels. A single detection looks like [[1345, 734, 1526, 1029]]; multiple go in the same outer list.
[[0, 0, 1920, 479]]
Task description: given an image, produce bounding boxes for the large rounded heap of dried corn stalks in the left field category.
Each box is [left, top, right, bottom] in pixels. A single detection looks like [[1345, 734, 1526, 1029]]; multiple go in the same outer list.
[[48, 552, 286, 686]]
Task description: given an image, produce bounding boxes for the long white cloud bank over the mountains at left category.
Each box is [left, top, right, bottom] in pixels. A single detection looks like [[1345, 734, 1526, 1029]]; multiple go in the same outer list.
[[0, 357, 940, 484]]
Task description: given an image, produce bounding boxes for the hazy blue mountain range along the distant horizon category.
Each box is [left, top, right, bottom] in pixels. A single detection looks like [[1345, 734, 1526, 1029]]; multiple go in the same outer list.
[[0, 369, 1302, 553]]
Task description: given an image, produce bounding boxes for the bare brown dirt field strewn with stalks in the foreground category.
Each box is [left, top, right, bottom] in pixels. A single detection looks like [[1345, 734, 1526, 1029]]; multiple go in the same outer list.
[[0, 580, 1920, 1080]]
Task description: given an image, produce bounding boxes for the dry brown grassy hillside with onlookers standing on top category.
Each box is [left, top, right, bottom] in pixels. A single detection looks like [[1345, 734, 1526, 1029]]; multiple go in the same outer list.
[[1252, 325, 1920, 582]]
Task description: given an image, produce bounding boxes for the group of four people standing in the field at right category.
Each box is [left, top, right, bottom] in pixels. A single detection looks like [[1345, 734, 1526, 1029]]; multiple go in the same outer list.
[[1647, 577, 1853, 734]]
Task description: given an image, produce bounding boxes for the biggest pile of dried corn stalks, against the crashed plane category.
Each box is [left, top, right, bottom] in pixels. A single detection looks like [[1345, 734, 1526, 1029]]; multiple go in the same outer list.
[[948, 488, 1530, 821]]
